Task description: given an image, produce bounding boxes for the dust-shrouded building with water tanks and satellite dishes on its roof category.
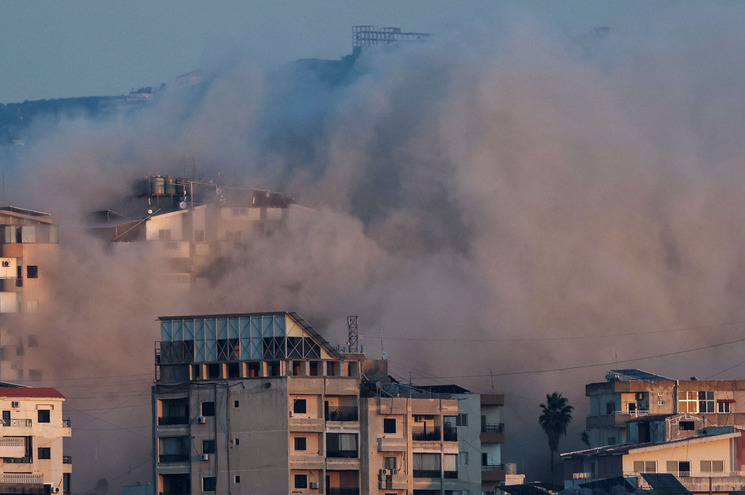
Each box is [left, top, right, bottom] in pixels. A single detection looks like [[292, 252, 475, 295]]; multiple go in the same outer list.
[[92, 175, 294, 287]]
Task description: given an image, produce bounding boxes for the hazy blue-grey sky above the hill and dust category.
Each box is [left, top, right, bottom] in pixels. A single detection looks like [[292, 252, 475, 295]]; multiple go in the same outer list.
[[0, 0, 676, 103]]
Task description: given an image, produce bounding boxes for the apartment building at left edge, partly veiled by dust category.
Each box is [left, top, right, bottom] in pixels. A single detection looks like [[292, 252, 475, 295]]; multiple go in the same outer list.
[[0, 206, 59, 381]]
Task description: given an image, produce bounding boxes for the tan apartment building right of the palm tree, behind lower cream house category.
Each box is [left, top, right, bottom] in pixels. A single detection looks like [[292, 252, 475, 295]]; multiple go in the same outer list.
[[585, 369, 745, 447]]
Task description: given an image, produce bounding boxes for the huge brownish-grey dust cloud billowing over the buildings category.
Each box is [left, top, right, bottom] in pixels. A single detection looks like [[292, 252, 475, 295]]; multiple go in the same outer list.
[[8, 6, 745, 488]]
